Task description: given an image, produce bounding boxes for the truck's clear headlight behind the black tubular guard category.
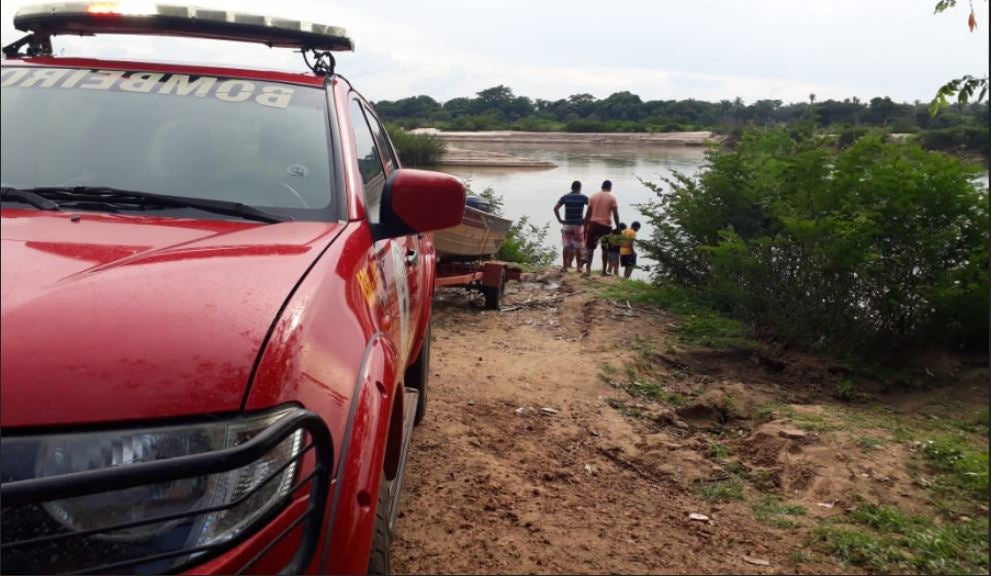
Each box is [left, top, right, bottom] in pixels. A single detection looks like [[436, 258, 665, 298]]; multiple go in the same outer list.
[[2, 408, 304, 572]]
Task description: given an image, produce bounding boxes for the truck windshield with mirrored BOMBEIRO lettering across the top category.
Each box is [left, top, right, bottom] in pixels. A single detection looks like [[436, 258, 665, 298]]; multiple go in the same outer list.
[[0, 67, 336, 220]]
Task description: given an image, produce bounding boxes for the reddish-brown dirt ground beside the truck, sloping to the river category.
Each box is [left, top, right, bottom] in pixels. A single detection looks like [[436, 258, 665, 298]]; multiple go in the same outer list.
[[392, 272, 987, 574]]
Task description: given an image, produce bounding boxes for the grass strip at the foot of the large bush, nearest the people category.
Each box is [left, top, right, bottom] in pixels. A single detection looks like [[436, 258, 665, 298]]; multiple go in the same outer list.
[[601, 280, 759, 350]]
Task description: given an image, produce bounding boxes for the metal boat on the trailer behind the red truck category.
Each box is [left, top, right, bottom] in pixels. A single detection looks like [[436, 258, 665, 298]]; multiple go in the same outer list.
[[434, 196, 513, 260]]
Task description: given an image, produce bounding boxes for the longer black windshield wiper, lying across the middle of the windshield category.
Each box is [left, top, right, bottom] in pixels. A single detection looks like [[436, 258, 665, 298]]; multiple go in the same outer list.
[[13, 186, 292, 223]]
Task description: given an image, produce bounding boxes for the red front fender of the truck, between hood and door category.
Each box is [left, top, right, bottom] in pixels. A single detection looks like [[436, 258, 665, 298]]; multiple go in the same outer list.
[[246, 226, 403, 574]]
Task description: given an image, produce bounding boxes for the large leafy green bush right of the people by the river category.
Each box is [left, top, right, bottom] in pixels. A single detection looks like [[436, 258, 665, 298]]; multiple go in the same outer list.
[[641, 127, 988, 352]]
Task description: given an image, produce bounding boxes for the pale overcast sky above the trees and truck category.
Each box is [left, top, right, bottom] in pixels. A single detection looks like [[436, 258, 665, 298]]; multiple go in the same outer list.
[[0, 0, 989, 103]]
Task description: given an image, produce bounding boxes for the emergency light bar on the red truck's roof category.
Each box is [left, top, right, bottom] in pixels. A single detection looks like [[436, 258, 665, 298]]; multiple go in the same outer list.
[[14, 1, 354, 51]]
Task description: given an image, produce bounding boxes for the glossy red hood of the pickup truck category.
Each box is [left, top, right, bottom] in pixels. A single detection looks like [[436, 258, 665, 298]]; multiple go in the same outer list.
[[0, 210, 344, 428]]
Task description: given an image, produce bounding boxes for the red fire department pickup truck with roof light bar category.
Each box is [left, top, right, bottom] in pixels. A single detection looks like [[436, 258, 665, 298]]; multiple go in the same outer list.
[[0, 2, 465, 574]]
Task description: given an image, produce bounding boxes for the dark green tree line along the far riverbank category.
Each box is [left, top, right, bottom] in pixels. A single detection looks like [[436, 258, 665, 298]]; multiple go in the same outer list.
[[375, 85, 988, 154]]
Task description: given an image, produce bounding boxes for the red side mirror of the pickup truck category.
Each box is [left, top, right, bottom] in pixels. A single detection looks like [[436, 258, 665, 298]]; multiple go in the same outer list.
[[375, 168, 466, 240]]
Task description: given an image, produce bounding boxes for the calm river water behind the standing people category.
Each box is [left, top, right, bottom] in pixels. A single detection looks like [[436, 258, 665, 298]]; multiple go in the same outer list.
[[444, 142, 705, 278]]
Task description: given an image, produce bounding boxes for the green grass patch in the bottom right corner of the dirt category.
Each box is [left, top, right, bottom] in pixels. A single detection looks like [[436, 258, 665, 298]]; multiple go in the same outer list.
[[809, 504, 988, 574]]
